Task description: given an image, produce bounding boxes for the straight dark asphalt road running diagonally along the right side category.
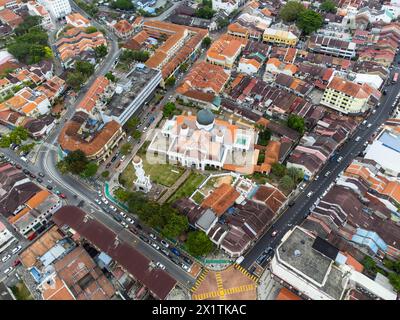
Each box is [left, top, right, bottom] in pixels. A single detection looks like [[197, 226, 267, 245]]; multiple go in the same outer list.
[[241, 55, 400, 269]]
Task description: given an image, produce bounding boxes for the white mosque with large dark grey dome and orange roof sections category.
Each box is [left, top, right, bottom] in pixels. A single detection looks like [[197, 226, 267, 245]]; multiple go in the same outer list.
[[148, 109, 257, 170]]
